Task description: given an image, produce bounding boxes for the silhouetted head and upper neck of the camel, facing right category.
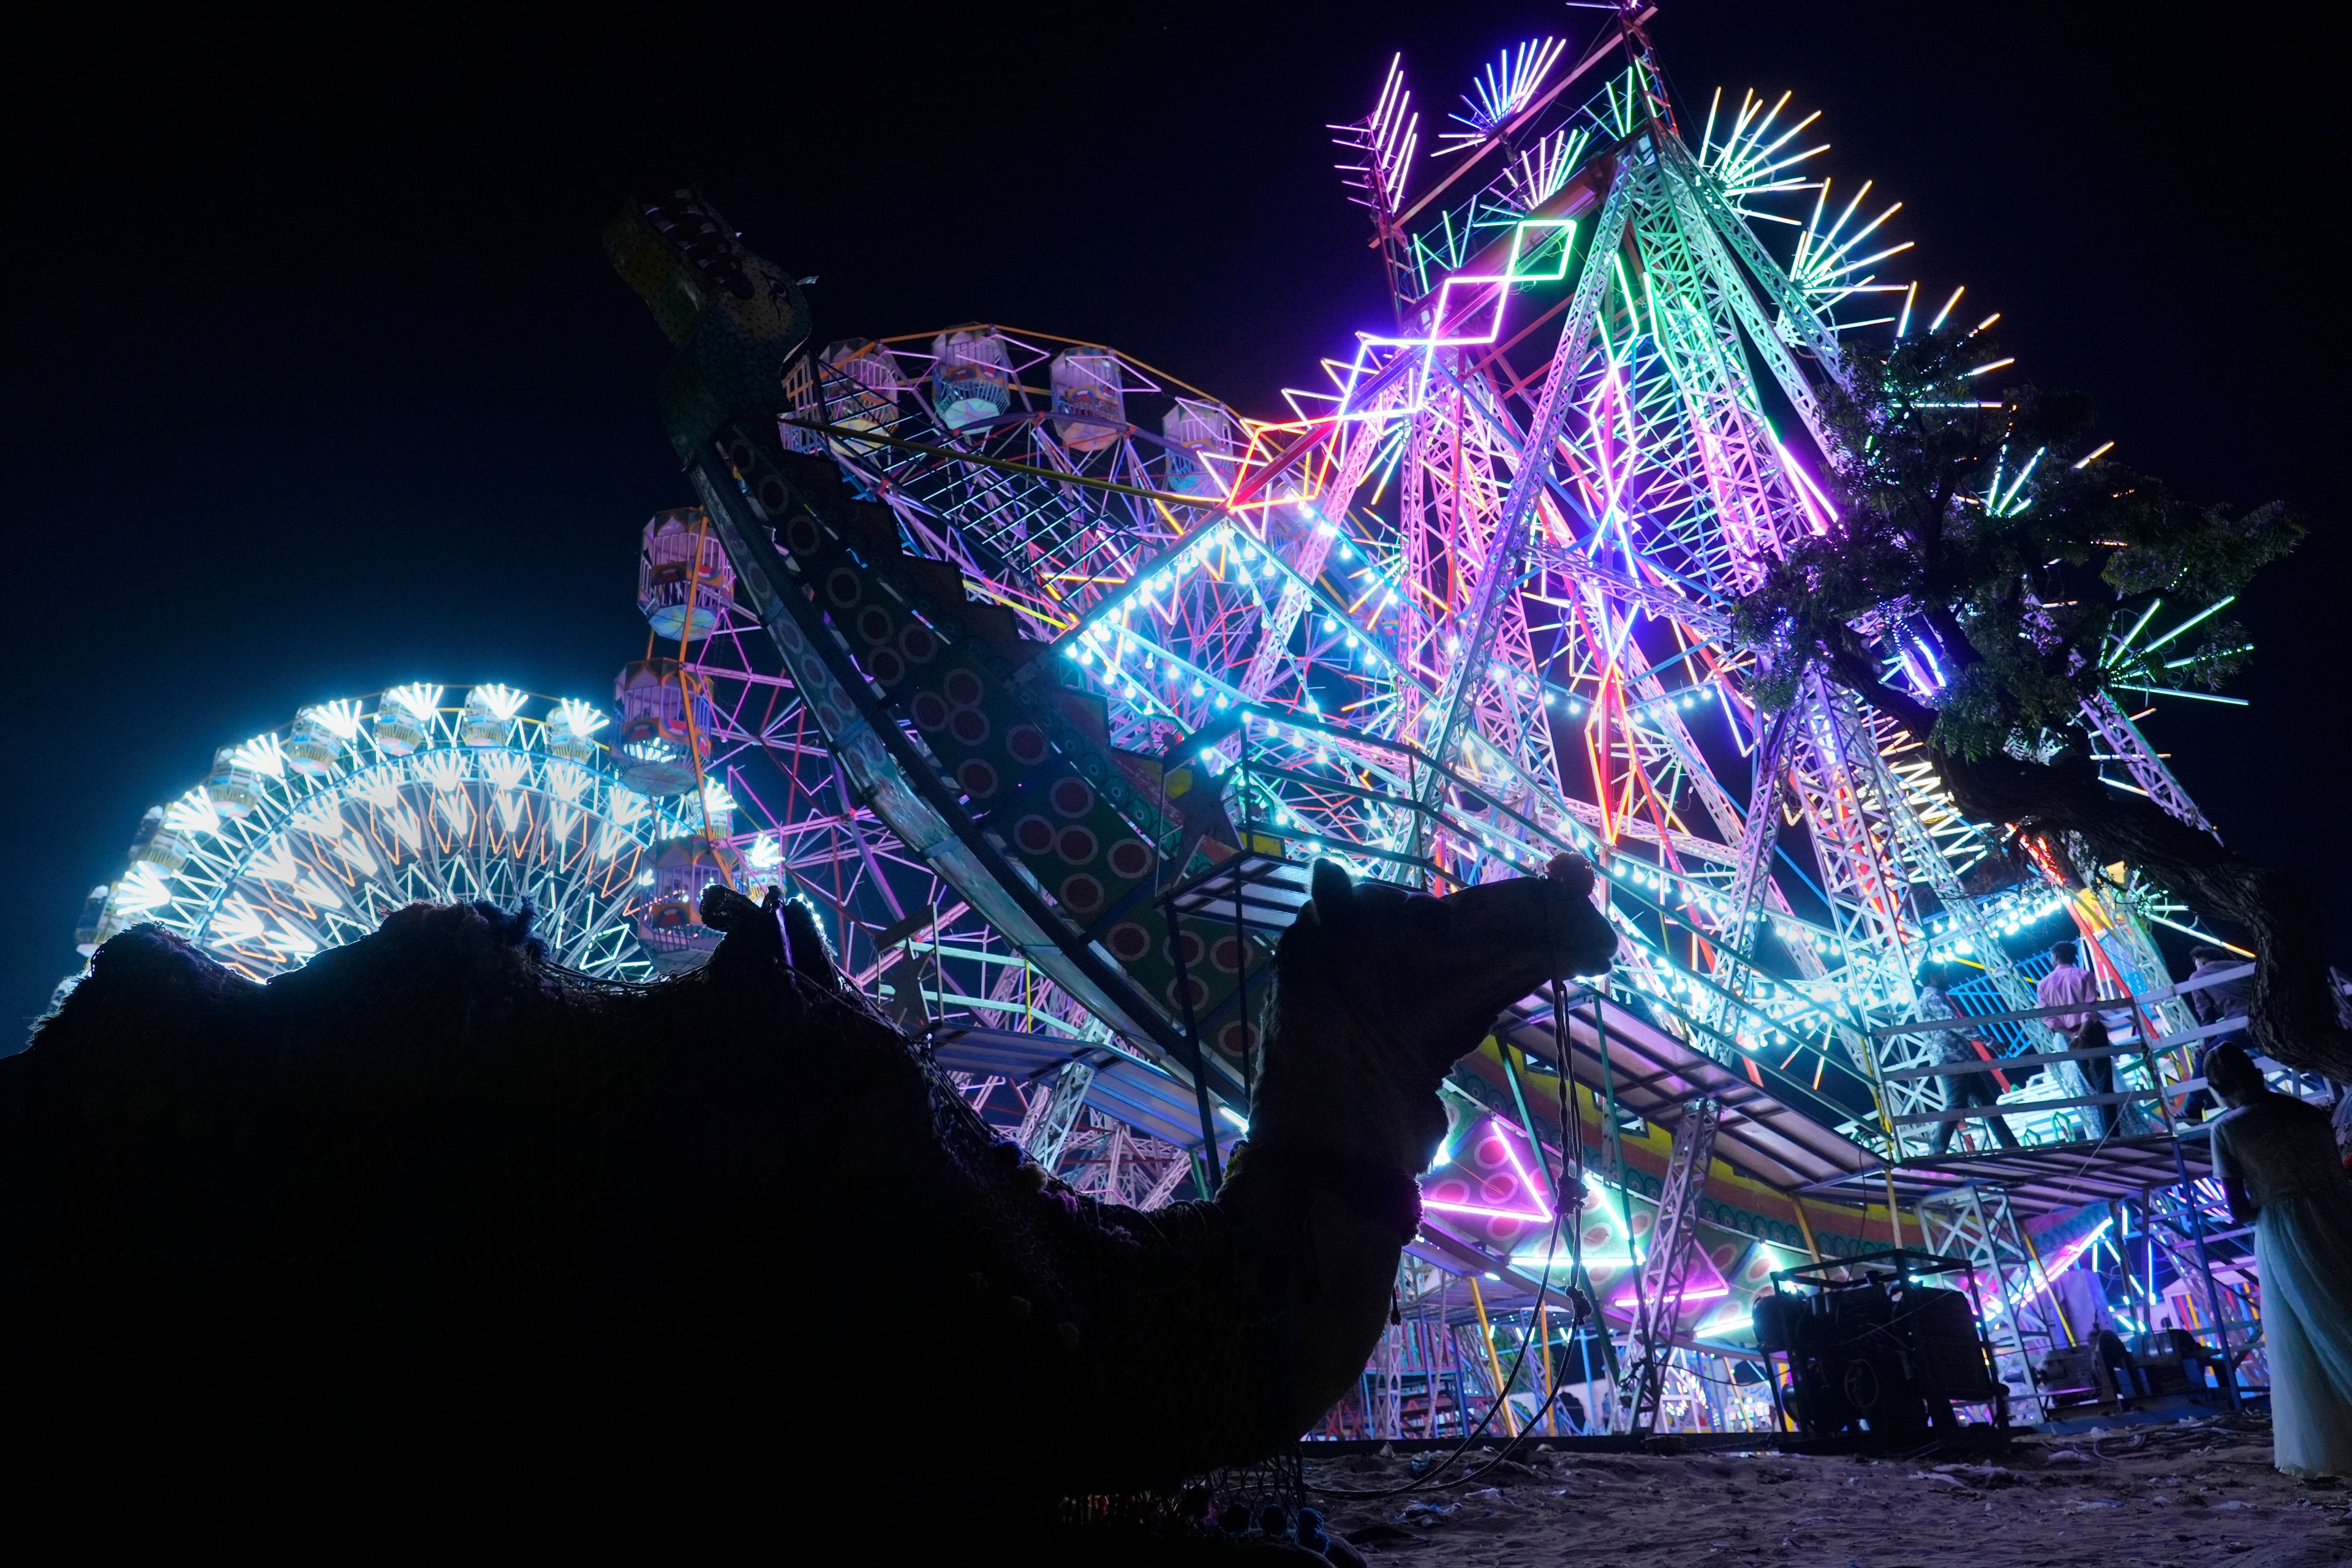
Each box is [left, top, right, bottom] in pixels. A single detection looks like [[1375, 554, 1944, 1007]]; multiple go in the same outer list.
[[1251, 856, 1616, 1170]]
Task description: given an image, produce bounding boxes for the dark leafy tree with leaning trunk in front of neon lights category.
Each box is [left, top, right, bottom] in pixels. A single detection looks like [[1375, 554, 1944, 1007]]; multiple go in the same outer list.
[[1736, 329, 2352, 1079]]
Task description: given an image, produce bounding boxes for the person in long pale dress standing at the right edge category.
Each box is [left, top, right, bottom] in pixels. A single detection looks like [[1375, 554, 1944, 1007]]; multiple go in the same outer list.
[[2206, 1046, 2352, 1476]]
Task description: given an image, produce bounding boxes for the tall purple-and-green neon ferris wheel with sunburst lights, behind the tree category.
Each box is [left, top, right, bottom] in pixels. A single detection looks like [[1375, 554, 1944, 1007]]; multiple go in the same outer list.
[[1296, 31, 2204, 1152]]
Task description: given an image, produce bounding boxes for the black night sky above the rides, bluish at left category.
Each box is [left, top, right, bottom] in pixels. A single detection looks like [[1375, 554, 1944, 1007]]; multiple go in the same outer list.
[[0, 0, 2352, 1032]]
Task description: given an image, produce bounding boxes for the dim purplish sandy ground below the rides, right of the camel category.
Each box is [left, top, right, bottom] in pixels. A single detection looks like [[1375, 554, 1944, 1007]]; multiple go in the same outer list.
[[1308, 1420, 2352, 1568]]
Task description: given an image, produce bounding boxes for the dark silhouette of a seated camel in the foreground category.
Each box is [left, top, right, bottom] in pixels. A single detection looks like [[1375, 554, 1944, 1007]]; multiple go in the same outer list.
[[0, 856, 1616, 1509]]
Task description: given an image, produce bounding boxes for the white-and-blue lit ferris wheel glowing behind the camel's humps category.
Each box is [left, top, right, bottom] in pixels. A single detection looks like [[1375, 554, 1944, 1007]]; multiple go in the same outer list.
[[75, 684, 731, 980]]
